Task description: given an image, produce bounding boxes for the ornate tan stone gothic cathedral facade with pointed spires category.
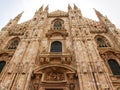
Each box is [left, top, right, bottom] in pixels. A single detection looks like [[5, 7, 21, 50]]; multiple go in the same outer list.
[[0, 5, 120, 90]]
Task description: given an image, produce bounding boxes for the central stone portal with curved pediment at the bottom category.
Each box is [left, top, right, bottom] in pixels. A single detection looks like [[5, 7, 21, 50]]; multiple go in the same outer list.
[[31, 65, 79, 90]]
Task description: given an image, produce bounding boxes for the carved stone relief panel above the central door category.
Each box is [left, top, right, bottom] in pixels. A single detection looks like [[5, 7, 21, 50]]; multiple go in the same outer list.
[[46, 71, 65, 81]]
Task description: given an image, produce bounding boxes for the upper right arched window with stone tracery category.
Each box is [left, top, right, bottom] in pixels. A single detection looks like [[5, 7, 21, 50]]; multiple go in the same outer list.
[[96, 36, 110, 47]]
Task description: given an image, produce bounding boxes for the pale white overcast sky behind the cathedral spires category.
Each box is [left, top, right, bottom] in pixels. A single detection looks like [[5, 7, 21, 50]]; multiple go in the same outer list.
[[0, 0, 120, 29]]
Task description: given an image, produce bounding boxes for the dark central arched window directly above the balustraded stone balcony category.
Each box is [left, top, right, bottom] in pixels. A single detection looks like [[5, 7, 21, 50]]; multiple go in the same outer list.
[[50, 41, 62, 52]]
